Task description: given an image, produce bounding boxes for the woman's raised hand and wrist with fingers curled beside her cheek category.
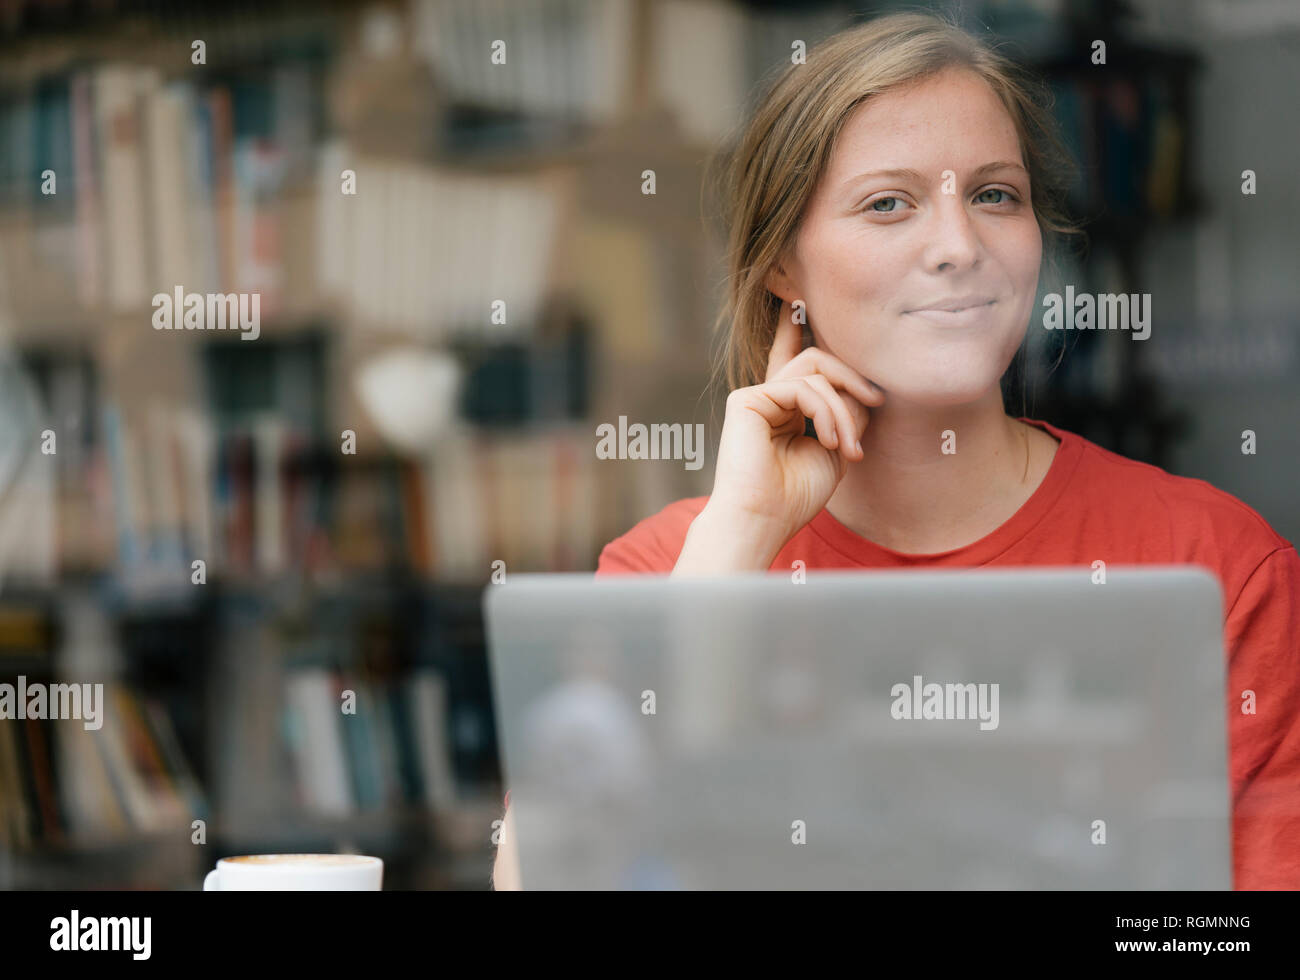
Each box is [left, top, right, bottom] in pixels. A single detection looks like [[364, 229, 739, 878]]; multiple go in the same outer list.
[[673, 303, 884, 574]]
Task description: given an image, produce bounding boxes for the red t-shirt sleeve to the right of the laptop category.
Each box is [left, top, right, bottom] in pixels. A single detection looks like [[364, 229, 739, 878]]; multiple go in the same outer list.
[[1225, 543, 1300, 890]]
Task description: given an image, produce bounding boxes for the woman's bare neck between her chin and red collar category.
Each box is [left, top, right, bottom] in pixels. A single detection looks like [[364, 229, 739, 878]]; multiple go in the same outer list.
[[827, 390, 1058, 555]]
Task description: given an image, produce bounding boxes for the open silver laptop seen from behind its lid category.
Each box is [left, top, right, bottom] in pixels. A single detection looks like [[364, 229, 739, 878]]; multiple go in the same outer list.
[[485, 565, 1232, 889]]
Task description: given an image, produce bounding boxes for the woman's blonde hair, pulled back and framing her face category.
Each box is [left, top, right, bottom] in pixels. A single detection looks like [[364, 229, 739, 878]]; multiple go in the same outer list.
[[706, 13, 1082, 389]]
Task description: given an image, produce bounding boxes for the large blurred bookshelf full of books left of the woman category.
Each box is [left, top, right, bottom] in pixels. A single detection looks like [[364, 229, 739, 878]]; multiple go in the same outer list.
[[0, 3, 691, 889]]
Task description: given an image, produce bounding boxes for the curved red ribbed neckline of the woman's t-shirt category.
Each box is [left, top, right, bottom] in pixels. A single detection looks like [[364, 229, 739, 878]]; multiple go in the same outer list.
[[807, 416, 1083, 565]]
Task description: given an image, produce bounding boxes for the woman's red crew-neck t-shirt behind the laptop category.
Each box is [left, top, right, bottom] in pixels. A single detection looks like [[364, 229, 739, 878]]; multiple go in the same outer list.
[[597, 419, 1300, 889]]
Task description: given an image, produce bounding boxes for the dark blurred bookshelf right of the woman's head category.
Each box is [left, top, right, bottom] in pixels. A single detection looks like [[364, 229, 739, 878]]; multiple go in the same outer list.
[[987, 0, 1205, 469]]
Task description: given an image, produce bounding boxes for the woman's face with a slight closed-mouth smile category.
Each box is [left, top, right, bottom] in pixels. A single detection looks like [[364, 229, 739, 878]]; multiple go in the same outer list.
[[768, 70, 1043, 406]]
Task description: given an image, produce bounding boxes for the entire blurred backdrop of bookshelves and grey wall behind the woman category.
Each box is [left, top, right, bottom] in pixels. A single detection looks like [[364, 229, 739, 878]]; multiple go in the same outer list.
[[0, 0, 1300, 889]]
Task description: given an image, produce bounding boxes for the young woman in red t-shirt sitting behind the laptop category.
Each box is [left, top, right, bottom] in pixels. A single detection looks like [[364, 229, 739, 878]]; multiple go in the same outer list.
[[495, 14, 1300, 889]]
